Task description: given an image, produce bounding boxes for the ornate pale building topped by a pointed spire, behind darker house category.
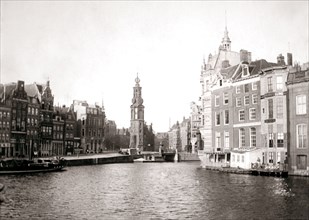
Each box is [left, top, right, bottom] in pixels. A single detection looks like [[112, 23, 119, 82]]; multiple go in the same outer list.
[[199, 28, 251, 165]]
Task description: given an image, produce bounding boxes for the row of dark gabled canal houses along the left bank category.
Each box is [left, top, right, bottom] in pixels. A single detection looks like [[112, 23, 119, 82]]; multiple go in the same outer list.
[[0, 81, 105, 158]]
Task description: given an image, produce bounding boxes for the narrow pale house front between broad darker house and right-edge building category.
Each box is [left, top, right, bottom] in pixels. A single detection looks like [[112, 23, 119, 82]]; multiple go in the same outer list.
[[261, 66, 288, 167]]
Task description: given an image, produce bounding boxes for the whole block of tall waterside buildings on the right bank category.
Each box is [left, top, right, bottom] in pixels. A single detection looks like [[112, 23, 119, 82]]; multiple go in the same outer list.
[[198, 26, 309, 175]]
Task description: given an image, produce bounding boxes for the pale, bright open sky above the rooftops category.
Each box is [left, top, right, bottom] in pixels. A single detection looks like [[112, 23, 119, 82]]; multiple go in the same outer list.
[[0, 0, 309, 132]]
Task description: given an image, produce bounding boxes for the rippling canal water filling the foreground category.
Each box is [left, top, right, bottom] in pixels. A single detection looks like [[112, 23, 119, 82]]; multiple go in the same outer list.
[[0, 162, 309, 220]]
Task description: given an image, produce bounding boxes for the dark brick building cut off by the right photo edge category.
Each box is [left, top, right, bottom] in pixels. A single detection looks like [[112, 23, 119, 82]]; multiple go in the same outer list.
[[287, 69, 309, 176]]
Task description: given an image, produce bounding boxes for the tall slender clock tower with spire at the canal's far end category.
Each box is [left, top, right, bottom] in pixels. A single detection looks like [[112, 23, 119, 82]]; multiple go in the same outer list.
[[130, 75, 144, 151]]
